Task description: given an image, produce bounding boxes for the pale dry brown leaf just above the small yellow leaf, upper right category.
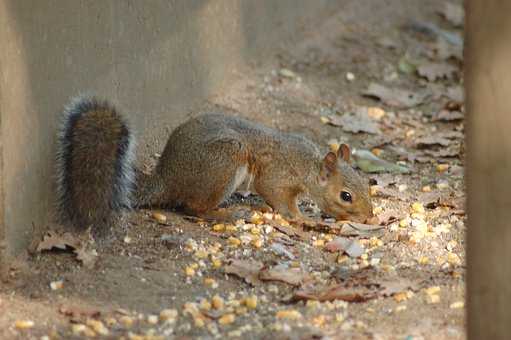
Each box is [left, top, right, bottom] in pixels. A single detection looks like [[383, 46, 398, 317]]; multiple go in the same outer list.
[[363, 83, 428, 108]]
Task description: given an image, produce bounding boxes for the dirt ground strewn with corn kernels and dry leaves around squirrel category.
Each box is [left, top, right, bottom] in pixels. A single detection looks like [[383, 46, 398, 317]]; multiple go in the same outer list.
[[0, 0, 466, 339]]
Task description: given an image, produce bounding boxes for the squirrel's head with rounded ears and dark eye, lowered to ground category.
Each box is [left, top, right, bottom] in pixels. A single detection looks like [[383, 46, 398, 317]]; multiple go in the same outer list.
[[314, 144, 373, 223]]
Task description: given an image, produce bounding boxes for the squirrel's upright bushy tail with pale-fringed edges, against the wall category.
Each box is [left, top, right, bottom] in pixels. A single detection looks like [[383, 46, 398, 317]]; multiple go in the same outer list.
[[56, 97, 135, 234]]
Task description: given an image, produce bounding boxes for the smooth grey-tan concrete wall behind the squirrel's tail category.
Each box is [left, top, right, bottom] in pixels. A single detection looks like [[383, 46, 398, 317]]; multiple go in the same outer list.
[[0, 0, 339, 253]]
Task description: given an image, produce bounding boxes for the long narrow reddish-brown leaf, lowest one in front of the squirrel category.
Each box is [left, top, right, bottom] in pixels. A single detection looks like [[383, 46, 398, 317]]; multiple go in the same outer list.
[[293, 285, 376, 302]]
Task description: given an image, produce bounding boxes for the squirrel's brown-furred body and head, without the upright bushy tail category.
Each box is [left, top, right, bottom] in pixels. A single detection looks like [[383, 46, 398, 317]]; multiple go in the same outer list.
[[139, 114, 372, 221]]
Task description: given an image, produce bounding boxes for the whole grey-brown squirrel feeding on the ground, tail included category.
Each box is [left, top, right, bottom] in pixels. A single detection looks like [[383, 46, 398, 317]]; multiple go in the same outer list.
[[56, 97, 373, 234]]
